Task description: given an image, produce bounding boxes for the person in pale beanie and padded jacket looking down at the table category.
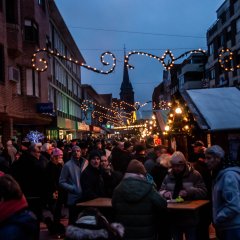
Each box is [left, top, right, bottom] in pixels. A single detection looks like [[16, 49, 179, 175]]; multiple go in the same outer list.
[[159, 151, 207, 240]]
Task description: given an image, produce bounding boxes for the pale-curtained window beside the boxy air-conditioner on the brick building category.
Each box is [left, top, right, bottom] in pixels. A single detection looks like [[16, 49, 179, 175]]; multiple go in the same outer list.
[[26, 69, 39, 97]]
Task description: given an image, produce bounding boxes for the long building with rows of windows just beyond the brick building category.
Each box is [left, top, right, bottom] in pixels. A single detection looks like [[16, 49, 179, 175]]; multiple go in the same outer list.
[[46, 0, 84, 140]]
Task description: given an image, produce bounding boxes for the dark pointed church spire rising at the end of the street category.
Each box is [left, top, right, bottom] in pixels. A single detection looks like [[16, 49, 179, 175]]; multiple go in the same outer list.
[[120, 46, 134, 104]]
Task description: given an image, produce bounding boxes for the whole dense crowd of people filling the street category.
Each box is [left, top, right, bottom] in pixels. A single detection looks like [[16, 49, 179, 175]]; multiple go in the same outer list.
[[0, 138, 240, 240]]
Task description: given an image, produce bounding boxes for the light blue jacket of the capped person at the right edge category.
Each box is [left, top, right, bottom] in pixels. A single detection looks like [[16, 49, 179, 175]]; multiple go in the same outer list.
[[212, 167, 240, 230]]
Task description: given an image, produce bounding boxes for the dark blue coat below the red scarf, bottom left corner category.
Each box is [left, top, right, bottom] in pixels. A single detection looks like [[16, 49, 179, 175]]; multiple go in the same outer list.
[[0, 210, 39, 240]]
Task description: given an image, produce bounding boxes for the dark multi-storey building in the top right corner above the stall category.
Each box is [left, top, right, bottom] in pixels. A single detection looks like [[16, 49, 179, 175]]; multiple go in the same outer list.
[[206, 0, 240, 87]]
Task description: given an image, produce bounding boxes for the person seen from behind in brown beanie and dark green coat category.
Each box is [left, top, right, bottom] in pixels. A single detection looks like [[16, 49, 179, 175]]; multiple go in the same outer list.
[[112, 159, 167, 240]]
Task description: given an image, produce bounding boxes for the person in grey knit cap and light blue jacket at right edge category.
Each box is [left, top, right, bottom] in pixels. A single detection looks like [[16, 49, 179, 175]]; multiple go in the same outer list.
[[205, 145, 240, 240]]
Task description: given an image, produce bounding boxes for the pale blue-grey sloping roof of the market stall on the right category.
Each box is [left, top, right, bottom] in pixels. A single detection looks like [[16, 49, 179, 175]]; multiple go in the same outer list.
[[186, 87, 240, 131]]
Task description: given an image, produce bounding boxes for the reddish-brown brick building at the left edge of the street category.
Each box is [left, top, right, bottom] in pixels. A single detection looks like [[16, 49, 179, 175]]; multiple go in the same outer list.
[[0, 0, 52, 143]]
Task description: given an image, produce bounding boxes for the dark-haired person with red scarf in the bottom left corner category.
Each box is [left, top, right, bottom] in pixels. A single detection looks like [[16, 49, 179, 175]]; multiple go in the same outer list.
[[0, 172, 39, 240]]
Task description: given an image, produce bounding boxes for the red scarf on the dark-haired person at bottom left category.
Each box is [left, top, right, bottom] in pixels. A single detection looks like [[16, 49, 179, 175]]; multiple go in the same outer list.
[[0, 195, 28, 223]]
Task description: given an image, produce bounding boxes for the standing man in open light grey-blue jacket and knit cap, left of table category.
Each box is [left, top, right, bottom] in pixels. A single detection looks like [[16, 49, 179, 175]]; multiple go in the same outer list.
[[59, 145, 88, 224]]
